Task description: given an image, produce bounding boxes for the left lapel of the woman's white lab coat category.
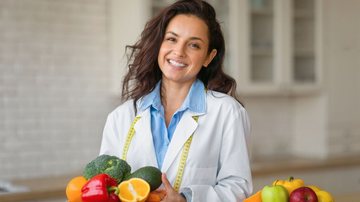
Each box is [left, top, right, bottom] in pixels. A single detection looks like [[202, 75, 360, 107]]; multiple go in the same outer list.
[[133, 108, 157, 167]]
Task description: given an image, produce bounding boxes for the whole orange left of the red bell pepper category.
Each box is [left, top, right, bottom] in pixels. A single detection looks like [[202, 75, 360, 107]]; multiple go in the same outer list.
[[66, 176, 87, 202]]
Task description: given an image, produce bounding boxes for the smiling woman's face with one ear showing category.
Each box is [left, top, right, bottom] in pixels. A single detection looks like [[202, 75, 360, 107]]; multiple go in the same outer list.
[[158, 14, 216, 84]]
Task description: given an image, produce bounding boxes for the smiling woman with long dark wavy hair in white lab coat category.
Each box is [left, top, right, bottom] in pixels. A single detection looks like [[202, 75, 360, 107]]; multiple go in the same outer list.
[[100, 0, 252, 202]]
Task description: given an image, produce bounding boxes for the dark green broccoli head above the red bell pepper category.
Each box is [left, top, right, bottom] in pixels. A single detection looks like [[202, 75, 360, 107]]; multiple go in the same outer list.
[[83, 154, 131, 183]]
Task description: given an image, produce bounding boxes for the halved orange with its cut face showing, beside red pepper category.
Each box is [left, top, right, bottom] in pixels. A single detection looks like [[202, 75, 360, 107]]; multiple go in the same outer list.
[[118, 178, 150, 202]]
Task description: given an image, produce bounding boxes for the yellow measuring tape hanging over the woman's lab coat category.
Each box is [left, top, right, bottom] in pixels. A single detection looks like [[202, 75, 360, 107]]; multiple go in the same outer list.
[[121, 116, 199, 191]]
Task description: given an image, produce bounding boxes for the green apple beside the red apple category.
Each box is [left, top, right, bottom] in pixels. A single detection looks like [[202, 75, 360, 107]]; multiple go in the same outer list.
[[261, 185, 289, 202]]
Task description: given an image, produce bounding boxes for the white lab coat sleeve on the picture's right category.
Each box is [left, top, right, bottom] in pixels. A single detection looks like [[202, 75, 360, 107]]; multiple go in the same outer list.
[[180, 108, 253, 202]]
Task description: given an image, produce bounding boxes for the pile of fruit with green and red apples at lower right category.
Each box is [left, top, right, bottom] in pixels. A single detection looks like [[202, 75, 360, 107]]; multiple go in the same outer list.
[[244, 177, 334, 202]]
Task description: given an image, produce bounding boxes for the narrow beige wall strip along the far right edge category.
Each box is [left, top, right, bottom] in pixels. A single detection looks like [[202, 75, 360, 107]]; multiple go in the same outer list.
[[324, 0, 360, 154]]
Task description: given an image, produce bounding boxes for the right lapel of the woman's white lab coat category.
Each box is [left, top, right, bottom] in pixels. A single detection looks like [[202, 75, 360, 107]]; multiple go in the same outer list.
[[161, 111, 198, 172]]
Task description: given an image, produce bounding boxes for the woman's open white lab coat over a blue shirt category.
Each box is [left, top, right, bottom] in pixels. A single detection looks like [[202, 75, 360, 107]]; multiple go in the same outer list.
[[100, 91, 252, 202]]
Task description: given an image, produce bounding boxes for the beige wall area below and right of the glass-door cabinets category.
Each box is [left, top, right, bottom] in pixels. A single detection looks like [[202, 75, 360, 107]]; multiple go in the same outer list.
[[245, 0, 360, 158]]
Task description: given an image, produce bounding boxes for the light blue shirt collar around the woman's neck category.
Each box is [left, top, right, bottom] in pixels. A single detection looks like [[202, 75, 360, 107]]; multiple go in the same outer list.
[[138, 79, 206, 113]]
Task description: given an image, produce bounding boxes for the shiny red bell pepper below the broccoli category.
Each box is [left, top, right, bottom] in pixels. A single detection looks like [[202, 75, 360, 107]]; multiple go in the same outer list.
[[81, 174, 120, 202]]
